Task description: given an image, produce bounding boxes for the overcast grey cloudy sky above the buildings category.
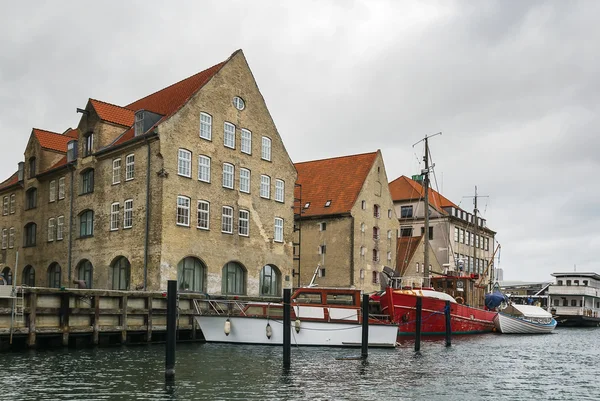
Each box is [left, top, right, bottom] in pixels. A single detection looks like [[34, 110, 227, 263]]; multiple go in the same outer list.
[[0, 0, 600, 281]]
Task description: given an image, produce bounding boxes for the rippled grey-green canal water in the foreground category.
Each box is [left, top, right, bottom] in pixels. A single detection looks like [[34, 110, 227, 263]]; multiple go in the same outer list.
[[0, 328, 600, 401]]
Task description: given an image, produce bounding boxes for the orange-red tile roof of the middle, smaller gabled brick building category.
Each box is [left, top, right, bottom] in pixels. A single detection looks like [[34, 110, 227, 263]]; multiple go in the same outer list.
[[295, 152, 378, 217]]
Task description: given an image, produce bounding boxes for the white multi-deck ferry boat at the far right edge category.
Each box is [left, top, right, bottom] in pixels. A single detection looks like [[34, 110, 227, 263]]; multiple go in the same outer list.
[[548, 272, 600, 327]]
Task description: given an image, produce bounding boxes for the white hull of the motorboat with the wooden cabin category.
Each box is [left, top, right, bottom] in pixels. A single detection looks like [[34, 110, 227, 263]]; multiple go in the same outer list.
[[196, 316, 398, 348]]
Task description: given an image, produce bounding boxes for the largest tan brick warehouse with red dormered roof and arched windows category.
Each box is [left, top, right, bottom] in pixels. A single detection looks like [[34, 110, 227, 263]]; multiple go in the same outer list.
[[0, 50, 296, 295]]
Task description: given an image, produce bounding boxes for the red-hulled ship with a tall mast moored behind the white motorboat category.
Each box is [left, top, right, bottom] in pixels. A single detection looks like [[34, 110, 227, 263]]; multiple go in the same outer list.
[[374, 134, 497, 336]]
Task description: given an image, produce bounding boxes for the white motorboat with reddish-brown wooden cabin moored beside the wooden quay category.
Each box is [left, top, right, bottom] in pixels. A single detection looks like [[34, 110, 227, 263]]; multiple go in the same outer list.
[[195, 288, 398, 347]]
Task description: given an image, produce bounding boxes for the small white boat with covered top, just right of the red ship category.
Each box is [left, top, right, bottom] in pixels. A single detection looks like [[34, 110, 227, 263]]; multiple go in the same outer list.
[[494, 304, 556, 334]]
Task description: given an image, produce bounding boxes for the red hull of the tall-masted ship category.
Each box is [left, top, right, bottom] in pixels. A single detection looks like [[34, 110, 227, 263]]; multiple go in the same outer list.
[[379, 288, 497, 336]]
